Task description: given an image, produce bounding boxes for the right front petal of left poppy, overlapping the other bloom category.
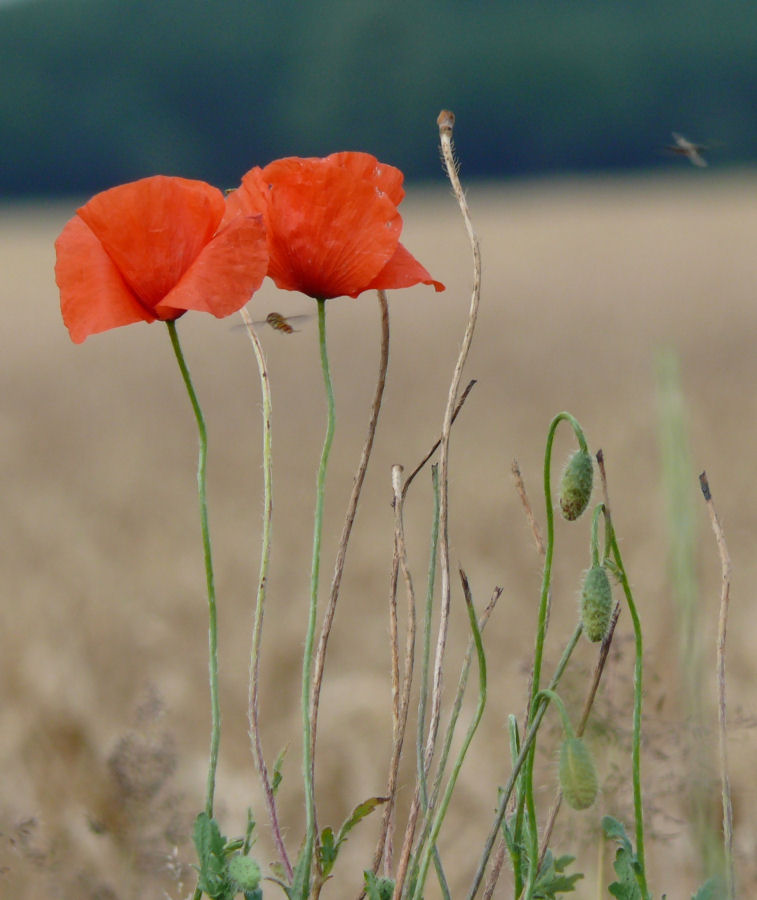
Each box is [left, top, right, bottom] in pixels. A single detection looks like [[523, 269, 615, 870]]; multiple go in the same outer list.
[[155, 216, 268, 318]]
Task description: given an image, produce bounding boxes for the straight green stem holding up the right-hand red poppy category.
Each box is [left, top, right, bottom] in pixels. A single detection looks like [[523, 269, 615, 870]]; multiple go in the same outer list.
[[297, 300, 335, 897]]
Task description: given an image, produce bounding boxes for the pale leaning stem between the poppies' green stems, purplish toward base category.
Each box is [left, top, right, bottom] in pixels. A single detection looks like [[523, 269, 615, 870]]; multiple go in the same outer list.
[[239, 306, 292, 881]]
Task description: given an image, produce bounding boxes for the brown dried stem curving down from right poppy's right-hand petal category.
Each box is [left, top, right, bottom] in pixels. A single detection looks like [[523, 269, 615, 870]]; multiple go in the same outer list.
[[310, 291, 389, 766]]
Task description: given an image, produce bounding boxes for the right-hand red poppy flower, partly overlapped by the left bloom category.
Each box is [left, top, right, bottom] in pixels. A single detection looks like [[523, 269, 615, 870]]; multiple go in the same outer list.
[[226, 152, 444, 300]]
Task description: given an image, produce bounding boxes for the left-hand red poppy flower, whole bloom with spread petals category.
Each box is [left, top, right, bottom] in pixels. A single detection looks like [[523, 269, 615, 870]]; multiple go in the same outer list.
[[55, 175, 268, 344]]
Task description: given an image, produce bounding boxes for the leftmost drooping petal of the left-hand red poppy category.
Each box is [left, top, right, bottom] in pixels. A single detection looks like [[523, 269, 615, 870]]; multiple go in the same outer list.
[[55, 216, 155, 344]]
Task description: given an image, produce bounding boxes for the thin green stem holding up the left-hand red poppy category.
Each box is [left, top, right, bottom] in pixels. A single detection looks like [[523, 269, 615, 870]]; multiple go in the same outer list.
[[166, 321, 221, 819]]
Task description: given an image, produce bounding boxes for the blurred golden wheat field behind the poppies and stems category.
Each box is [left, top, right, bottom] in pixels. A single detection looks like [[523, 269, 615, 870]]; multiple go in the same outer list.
[[0, 169, 757, 900]]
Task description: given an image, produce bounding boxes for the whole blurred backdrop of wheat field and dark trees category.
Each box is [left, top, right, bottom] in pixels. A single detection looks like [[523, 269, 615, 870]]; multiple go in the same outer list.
[[0, 0, 757, 900]]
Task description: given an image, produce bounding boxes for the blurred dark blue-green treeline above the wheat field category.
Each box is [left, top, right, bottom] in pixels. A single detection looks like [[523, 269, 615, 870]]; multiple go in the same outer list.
[[0, 0, 757, 196]]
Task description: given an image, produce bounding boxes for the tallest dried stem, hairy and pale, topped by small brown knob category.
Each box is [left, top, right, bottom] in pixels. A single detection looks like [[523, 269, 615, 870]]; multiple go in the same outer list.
[[426, 110, 481, 788]]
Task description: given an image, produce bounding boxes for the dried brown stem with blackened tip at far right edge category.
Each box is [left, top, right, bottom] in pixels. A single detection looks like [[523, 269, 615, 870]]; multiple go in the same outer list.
[[699, 472, 736, 900]]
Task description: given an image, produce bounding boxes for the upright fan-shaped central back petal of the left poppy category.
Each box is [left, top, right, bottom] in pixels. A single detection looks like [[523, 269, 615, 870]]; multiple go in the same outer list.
[[78, 175, 225, 309]]
